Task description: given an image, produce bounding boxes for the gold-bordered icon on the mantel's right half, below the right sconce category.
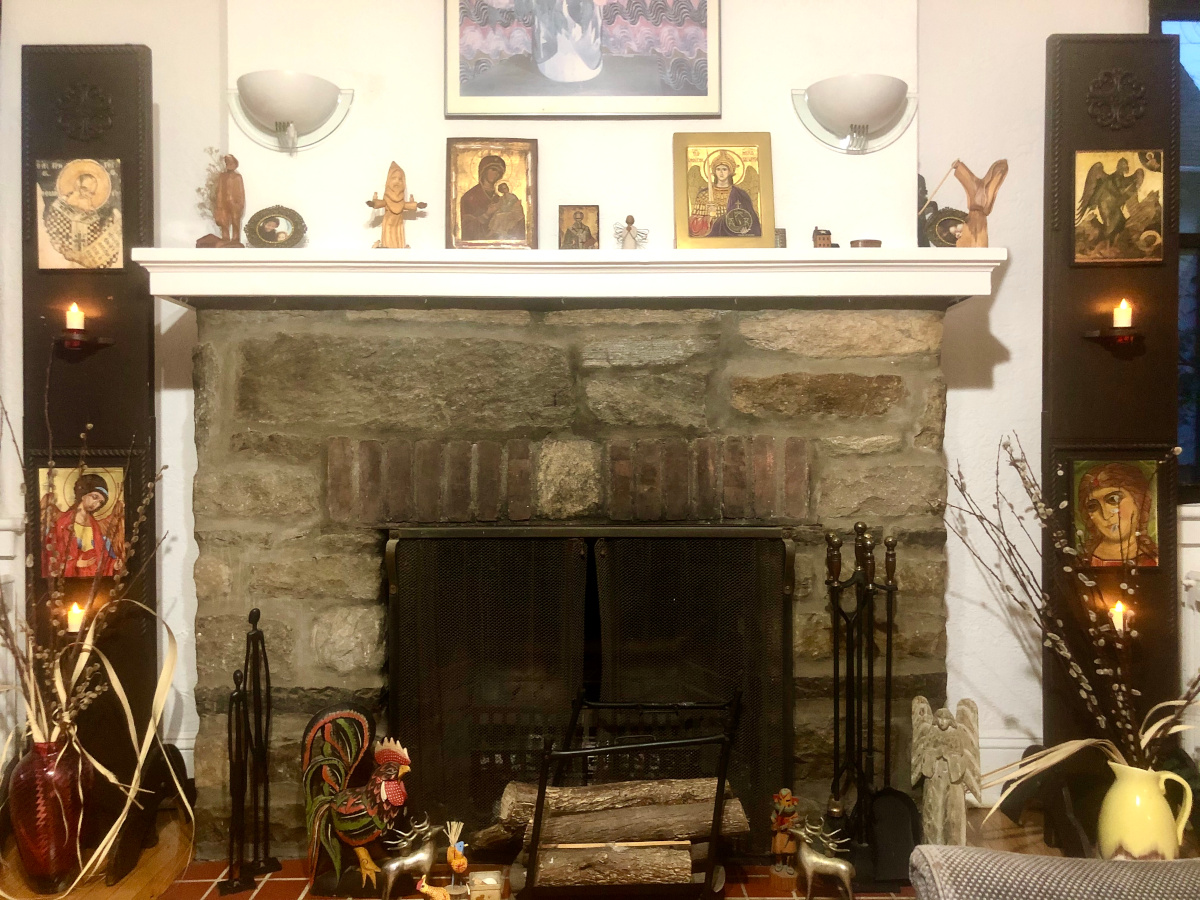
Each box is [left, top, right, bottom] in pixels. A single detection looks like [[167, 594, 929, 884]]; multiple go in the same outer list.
[[674, 132, 775, 248]]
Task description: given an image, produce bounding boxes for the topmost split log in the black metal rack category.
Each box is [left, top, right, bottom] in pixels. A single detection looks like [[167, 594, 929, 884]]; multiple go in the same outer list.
[[498, 778, 733, 830]]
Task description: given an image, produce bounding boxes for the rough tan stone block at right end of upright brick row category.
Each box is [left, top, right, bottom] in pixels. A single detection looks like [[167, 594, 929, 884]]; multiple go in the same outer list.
[[817, 464, 946, 518]]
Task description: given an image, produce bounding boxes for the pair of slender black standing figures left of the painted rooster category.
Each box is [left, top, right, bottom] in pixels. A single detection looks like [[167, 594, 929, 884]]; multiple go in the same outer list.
[[217, 608, 282, 895]]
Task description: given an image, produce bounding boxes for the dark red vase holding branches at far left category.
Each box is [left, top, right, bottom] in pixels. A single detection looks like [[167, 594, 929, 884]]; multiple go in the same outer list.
[[8, 740, 91, 894]]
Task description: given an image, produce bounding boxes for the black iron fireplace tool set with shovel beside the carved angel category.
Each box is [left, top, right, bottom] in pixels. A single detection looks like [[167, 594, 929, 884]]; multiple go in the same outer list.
[[826, 522, 920, 887]]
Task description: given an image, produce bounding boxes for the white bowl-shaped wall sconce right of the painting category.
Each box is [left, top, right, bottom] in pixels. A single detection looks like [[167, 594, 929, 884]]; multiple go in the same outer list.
[[792, 74, 917, 154]]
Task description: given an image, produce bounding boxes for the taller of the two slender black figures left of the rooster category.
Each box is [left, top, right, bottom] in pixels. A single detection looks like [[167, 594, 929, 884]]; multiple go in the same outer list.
[[245, 608, 282, 875]]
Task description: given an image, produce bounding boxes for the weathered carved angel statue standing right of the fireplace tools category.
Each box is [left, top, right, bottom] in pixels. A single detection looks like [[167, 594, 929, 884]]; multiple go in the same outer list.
[[912, 697, 983, 846]]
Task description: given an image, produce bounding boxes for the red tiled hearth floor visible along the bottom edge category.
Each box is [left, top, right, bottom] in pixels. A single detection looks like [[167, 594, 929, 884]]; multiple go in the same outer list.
[[161, 859, 913, 900]]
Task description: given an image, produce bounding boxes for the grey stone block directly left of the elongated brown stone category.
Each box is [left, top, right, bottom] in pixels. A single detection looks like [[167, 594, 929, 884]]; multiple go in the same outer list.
[[586, 372, 708, 428]]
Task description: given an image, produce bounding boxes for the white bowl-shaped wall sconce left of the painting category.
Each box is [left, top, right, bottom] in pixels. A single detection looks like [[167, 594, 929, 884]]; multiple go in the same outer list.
[[229, 68, 354, 154]]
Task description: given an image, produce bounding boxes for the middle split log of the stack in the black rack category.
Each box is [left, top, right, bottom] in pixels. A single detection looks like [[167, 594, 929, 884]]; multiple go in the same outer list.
[[524, 798, 750, 846]]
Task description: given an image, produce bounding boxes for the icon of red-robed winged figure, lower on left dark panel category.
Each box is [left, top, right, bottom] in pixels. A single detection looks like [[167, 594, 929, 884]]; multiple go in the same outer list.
[[42, 472, 125, 578]]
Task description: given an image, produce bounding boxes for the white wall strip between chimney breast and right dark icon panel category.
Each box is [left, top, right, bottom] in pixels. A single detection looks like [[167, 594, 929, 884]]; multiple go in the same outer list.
[[919, 0, 1148, 787]]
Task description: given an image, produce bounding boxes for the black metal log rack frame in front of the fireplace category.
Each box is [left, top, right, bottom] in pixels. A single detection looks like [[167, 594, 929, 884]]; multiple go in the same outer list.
[[515, 690, 742, 900]]
